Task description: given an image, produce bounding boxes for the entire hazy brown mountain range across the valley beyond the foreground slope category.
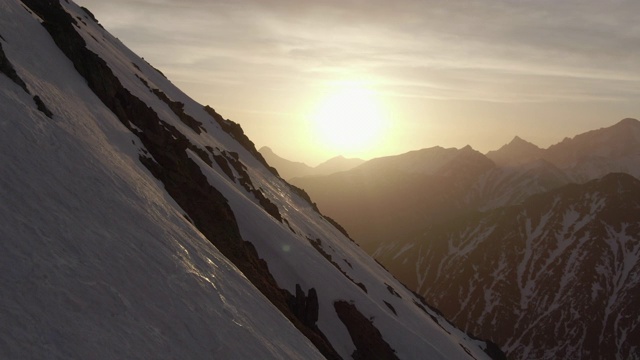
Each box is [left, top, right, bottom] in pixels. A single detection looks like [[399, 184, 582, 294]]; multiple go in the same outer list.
[[292, 119, 640, 359]]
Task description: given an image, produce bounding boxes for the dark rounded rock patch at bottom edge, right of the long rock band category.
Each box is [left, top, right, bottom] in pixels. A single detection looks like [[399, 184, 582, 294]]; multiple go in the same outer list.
[[333, 301, 398, 360]]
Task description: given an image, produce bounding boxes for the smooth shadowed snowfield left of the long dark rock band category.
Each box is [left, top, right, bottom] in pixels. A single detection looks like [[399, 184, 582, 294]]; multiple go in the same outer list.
[[0, 1, 322, 359]]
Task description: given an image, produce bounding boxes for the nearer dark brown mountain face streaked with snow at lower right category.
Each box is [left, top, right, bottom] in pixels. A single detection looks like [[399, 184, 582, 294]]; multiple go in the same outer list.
[[378, 174, 640, 359]]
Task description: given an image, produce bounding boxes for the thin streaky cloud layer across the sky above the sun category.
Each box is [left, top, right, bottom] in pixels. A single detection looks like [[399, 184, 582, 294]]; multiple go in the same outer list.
[[81, 0, 640, 102]]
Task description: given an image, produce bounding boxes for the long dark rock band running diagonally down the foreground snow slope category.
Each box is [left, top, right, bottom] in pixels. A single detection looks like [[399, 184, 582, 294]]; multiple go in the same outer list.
[[24, 0, 340, 359]]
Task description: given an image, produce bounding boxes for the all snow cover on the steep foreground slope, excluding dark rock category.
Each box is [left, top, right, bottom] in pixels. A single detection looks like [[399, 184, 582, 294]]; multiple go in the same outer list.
[[0, 0, 487, 359]]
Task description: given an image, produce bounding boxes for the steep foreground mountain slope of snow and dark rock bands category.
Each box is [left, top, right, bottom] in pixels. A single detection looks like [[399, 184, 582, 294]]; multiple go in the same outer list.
[[0, 0, 501, 359]]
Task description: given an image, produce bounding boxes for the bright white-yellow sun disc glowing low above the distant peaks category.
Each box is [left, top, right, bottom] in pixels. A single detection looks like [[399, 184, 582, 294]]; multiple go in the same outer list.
[[312, 87, 386, 156]]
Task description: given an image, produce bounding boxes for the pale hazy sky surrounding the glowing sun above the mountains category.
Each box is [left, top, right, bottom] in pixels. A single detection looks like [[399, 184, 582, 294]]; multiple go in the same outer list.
[[76, 0, 640, 164]]
